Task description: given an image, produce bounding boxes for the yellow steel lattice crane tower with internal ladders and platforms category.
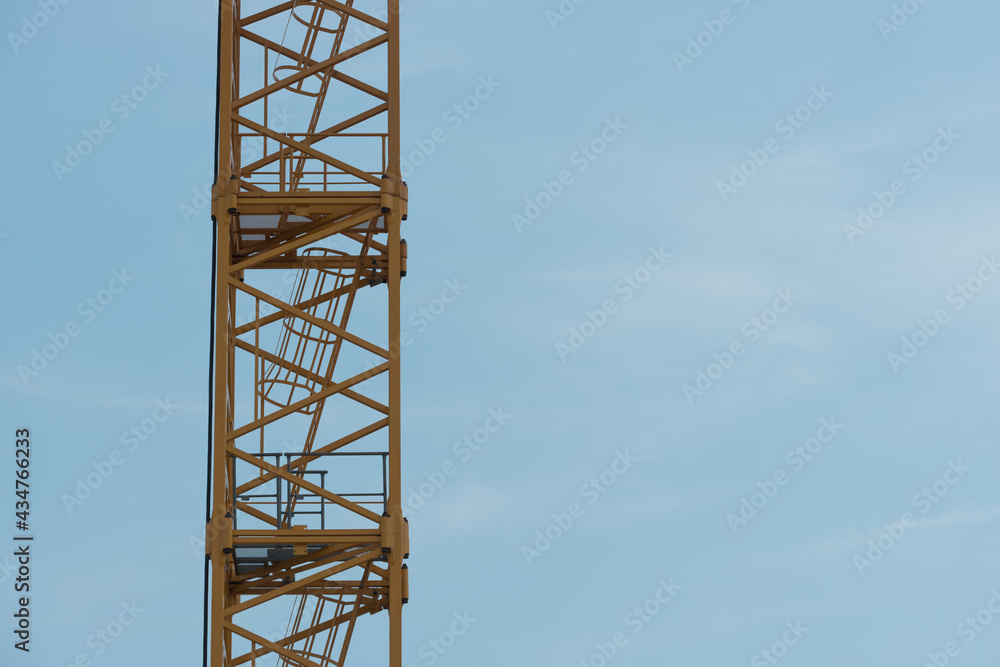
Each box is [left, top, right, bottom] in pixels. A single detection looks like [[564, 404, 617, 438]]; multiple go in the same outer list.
[[205, 0, 409, 667]]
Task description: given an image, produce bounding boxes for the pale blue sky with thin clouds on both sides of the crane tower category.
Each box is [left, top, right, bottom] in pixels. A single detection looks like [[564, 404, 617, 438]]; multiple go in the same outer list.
[[0, 0, 1000, 667]]
